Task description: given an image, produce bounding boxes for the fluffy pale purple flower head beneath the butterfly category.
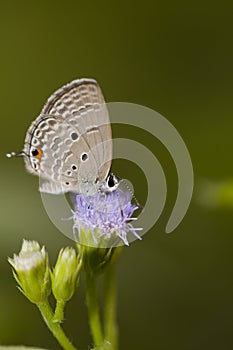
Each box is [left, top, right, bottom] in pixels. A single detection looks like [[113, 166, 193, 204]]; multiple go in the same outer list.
[[72, 189, 141, 247]]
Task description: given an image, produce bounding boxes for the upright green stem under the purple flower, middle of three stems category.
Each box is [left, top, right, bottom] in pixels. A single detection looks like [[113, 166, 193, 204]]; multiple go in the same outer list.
[[86, 273, 104, 346]]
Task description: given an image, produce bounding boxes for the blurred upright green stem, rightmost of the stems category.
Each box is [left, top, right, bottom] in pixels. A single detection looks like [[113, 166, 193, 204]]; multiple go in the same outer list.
[[104, 263, 118, 350]]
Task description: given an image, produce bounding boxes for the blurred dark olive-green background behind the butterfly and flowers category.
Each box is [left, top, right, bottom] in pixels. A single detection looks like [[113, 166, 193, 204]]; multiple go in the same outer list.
[[0, 0, 233, 350]]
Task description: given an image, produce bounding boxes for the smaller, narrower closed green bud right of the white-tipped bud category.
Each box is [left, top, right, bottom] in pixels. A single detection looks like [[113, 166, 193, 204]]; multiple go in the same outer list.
[[51, 247, 81, 302]]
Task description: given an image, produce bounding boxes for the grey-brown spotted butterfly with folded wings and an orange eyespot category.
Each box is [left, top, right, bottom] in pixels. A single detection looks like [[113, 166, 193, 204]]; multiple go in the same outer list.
[[7, 79, 117, 195]]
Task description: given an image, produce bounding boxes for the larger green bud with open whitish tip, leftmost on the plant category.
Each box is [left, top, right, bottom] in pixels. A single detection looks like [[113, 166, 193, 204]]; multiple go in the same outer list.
[[8, 240, 51, 304]]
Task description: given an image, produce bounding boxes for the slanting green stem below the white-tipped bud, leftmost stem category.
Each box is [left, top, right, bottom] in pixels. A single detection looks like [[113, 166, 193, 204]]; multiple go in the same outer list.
[[37, 301, 77, 350]]
